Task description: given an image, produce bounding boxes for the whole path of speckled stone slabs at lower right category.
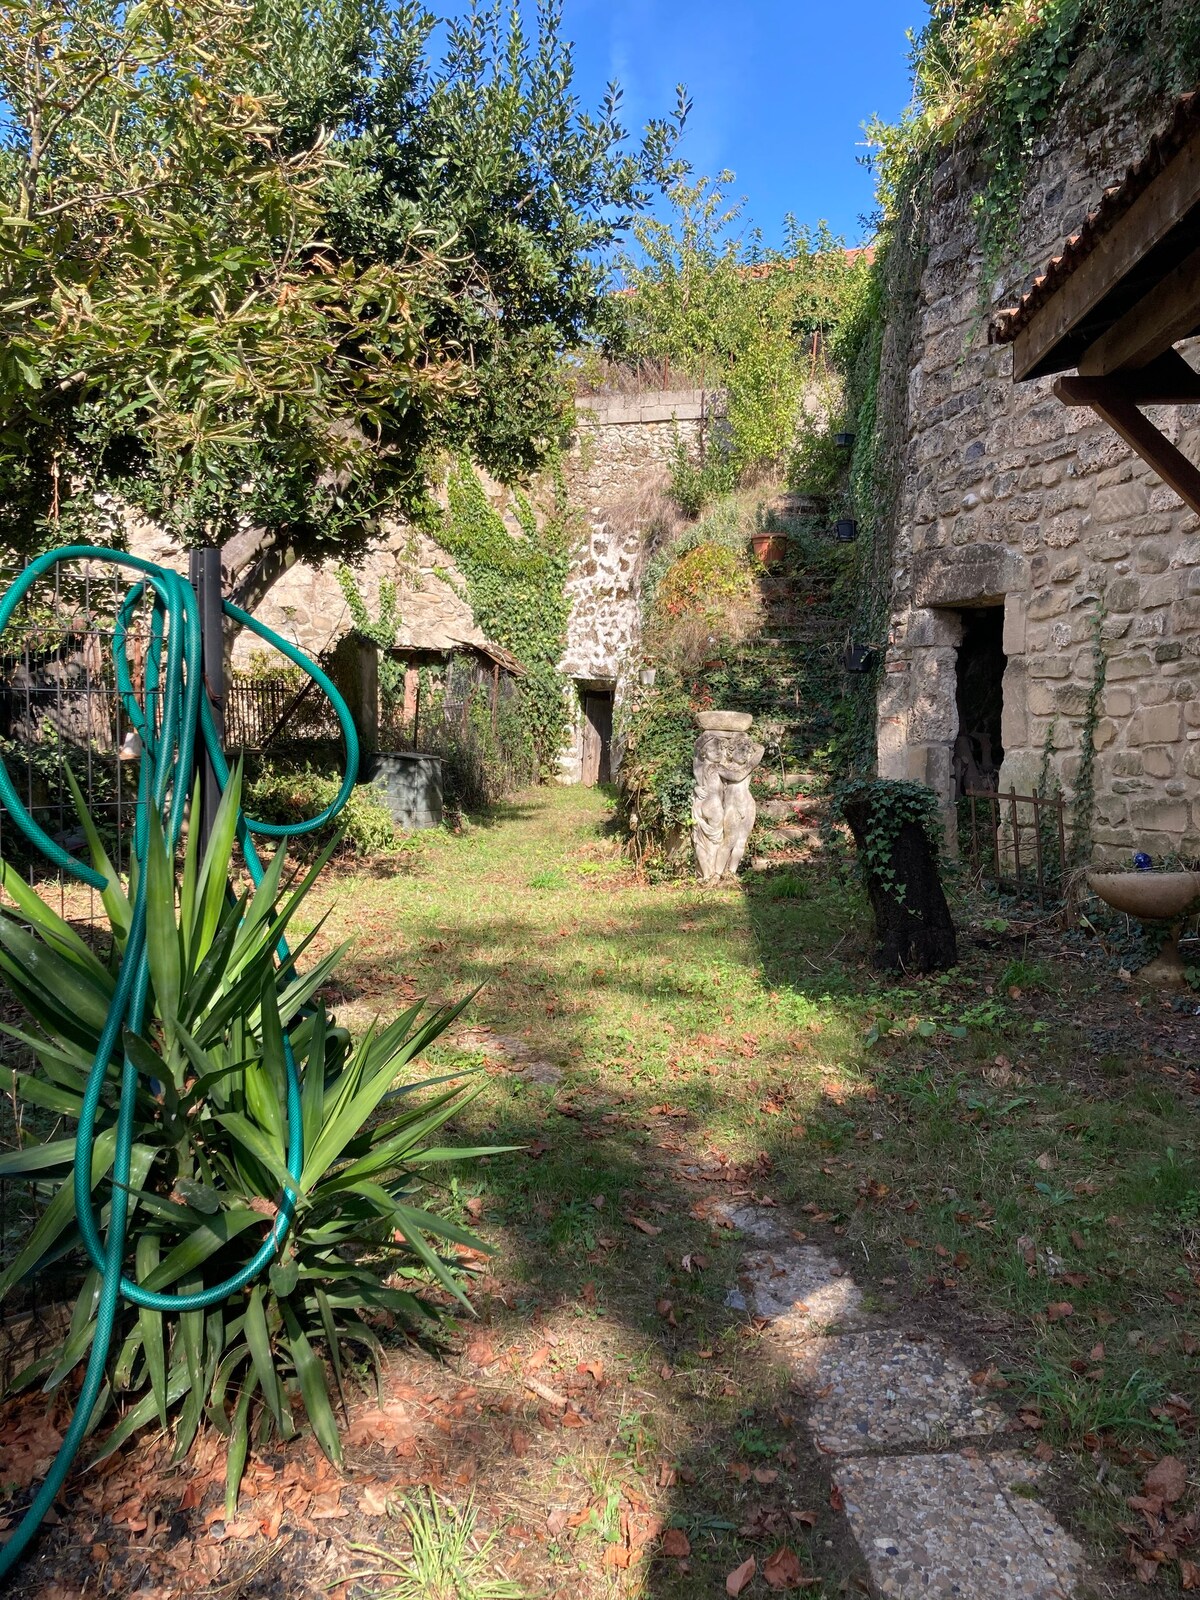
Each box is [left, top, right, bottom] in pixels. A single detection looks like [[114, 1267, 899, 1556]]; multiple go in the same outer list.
[[726, 1206, 1093, 1600]]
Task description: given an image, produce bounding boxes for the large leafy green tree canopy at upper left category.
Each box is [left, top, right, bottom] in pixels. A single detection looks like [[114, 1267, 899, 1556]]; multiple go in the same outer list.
[[0, 0, 685, 603]]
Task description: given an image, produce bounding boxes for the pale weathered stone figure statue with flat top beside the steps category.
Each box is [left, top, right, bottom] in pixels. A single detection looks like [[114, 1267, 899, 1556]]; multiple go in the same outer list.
[[691, 710, 763, 885]]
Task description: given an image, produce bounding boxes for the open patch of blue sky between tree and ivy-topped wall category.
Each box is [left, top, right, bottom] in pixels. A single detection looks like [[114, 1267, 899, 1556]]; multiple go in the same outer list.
[[563, 0, 928, 245]]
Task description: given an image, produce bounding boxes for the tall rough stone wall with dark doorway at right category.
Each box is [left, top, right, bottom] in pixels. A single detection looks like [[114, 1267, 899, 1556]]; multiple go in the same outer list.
[[878, 84, 1200, 859]]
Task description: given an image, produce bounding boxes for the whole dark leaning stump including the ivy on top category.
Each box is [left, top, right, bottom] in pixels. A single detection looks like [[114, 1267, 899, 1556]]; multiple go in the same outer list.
[[838, 779, 958, 973]]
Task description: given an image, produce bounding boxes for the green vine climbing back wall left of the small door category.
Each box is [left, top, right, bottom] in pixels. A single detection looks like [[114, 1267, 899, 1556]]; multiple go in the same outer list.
[[438, 461, 574, 776]]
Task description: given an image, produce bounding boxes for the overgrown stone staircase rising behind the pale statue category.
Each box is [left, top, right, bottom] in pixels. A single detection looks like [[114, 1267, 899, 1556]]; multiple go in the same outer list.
[[717, 541, 854, 862]]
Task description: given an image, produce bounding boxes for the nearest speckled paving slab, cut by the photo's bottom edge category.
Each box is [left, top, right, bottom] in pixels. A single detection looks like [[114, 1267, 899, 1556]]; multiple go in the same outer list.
[[834, 1453, 1086, 1600]]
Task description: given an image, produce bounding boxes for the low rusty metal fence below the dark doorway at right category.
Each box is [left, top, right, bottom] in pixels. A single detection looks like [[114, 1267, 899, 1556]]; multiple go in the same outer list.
[[958, 789, 1069, 907]]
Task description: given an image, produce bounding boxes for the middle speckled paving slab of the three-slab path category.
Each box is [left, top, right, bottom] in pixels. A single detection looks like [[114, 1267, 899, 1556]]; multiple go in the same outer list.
[[794, 1328, 1005, 1456]]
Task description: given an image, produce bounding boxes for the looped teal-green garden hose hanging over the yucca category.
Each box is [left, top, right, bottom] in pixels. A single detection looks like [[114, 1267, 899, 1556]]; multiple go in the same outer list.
[[0, 544, 358, 1579]]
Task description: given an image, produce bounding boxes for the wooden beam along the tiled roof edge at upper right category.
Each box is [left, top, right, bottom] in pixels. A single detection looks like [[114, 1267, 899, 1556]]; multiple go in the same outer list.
[[1013, 136, 1200, 382]]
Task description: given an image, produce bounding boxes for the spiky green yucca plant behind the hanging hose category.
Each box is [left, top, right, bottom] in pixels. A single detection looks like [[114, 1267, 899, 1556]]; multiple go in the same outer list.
[[0, 776, 498, 1514]]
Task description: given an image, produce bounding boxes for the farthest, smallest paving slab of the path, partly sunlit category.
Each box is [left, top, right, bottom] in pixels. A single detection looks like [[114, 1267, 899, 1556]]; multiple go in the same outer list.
[[728, 1206, 862, 1338]]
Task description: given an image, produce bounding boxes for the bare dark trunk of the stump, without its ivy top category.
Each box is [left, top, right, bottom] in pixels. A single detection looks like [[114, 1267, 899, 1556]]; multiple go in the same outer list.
[[842, 800, 958, 973]]
